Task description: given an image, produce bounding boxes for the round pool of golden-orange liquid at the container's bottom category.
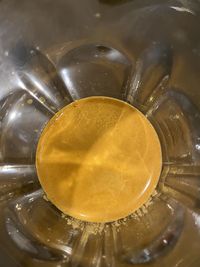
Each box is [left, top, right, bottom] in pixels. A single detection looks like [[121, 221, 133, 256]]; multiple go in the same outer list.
[[36, 97, 162, 222]]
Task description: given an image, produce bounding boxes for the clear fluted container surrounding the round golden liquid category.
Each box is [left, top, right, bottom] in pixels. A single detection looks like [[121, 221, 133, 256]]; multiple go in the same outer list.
[[0, 0, 200, 267]]
